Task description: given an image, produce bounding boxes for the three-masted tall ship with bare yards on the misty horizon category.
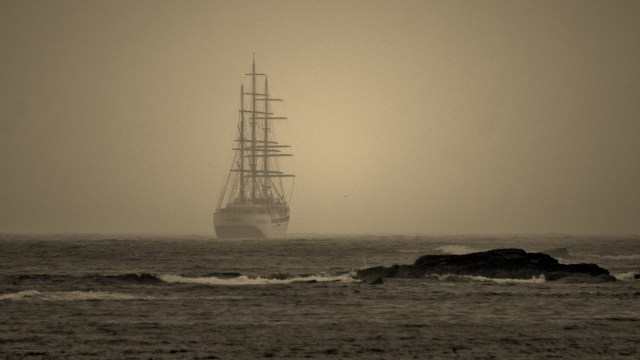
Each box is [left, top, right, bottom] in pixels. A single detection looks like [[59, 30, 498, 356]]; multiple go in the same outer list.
[[213, 59, 294, 238]]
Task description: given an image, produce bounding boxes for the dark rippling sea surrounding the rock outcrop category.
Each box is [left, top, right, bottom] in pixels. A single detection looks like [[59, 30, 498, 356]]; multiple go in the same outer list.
[[0, 234, 640, 359]]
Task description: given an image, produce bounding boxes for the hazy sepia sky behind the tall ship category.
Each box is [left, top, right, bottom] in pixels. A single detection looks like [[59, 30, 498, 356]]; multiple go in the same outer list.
[[0, 0, 640, 234]]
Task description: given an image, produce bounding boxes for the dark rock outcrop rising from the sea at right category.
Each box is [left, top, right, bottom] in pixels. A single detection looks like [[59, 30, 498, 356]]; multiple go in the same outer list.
[[356, 249, 615, 283]]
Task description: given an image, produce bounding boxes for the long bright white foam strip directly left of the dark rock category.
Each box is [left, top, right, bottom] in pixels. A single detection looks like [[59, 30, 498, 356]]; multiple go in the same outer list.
[[158, 274, 355, 286]]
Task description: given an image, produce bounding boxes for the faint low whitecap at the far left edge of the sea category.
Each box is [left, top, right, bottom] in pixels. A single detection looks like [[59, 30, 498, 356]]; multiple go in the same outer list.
[[0, 290, 143, 301]]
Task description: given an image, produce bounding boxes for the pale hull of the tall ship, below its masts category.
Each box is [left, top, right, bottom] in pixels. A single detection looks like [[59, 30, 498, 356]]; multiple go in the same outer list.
[[213, 213, 289, 239]]
